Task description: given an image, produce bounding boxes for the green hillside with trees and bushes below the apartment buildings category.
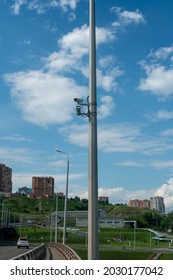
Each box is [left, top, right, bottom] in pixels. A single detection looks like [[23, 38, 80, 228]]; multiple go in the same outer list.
[[0, 197, 173, 230]]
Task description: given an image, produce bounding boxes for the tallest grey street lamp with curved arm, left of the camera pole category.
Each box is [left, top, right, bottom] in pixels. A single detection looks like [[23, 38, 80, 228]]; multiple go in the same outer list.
[[55, 149, 69, 244]]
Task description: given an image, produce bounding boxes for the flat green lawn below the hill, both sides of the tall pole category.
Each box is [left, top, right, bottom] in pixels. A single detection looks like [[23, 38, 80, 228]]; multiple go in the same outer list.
[[13, 226, 173, 260]]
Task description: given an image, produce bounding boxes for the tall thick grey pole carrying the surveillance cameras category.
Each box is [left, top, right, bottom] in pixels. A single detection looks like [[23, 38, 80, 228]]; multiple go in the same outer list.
[[88, 0, 98, 260]]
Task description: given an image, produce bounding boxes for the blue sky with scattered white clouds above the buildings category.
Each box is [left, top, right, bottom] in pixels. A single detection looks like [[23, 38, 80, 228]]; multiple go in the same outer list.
[[0, 0, 173, 210]]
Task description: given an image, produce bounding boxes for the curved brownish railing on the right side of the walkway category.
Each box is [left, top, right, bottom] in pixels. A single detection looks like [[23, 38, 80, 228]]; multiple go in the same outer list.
[[48, 243, 81, 260]]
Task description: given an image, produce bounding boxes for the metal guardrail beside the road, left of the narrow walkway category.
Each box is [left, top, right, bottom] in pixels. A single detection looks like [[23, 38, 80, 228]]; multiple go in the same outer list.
[[11, 243, 46, 260]]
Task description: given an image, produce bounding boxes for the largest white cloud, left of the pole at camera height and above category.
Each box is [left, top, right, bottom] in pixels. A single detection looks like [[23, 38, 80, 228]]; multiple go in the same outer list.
[[4, 71, 87, 126]]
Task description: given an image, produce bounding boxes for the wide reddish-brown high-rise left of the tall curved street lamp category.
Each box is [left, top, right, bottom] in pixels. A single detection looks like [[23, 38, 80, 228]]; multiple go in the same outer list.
[[32, 177, 54, 197]]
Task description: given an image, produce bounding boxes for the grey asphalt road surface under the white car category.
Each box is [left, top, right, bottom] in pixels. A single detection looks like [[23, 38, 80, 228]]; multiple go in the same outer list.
[[0, 243, 35, 260]]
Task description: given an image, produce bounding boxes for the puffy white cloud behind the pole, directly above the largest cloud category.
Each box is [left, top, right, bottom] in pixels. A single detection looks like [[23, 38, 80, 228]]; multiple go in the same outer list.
[[46, 25, 114, 74]]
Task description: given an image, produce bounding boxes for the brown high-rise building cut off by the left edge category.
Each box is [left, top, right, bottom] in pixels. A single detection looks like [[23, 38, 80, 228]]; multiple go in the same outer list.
[[0, 163, 12, 194]]
